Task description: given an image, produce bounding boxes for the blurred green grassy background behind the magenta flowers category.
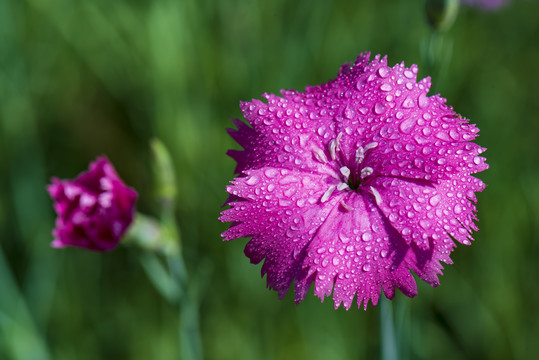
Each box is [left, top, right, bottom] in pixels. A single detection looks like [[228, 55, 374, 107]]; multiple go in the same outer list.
[[0, 0, 539, 360]]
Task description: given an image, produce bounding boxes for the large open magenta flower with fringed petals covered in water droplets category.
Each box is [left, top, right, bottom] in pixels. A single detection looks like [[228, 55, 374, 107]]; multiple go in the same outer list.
[[220, 53, 488, 309]]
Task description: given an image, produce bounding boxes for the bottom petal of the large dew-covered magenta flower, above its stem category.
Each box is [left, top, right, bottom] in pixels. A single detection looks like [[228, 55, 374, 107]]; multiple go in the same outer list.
[[305, 192, 417, 309]]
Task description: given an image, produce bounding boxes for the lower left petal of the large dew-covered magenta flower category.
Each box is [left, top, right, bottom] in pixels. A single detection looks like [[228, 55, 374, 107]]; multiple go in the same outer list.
[[220, 168, 336, 297]]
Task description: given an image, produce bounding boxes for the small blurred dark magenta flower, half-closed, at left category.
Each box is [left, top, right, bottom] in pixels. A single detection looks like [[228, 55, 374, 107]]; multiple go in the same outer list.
[[47, 157, 137, 251]]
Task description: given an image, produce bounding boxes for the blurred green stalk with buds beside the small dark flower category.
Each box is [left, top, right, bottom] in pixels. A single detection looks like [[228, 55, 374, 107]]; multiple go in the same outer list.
[[124, 139, 202, 360]]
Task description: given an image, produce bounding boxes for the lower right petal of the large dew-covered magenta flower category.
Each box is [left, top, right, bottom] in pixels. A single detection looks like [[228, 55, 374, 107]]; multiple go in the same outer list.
[[373, 175, 485, 250]]
